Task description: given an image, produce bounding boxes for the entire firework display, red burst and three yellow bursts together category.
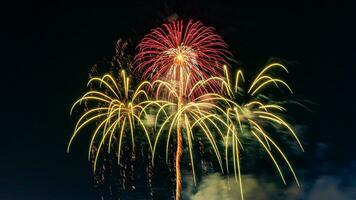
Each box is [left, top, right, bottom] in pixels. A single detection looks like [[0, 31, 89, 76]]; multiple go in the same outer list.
[[67, 21, 304, 200]]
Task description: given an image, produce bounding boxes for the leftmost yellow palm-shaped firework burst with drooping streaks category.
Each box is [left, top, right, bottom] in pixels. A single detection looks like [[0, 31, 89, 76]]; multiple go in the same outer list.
[[67, 70, 152, 172]]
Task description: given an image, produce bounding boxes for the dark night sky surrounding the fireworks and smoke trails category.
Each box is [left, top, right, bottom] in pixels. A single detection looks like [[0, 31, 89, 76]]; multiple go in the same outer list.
[[0, 0, 356, 200]]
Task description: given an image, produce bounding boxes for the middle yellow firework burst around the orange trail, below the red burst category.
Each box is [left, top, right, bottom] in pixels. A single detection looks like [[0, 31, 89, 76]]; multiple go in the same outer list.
[[146, 68, 227, 189]]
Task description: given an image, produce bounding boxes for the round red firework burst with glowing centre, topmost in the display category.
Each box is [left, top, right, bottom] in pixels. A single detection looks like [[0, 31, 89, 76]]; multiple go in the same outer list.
[[134, 21, 230, 100]]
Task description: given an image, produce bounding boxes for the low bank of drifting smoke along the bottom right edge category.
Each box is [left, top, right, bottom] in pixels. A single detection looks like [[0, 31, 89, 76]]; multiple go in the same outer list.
[[184, 167, 356, 200]]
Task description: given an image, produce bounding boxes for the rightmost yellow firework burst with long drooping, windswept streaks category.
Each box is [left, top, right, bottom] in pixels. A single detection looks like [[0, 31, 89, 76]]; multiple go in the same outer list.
[[217, 63, 304, 199]]
